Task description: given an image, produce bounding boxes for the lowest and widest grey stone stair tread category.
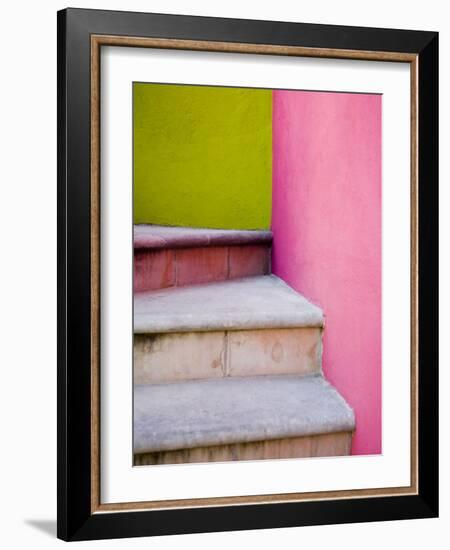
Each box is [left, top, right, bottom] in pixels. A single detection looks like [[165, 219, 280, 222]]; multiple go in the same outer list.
[[134, 375, 355, 453]]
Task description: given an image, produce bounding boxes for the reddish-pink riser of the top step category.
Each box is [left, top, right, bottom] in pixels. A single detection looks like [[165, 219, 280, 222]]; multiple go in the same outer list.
[[134, 244, 270, 292]]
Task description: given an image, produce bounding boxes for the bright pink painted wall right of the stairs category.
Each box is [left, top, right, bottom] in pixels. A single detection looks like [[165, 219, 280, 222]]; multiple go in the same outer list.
[[272, 91, 381, 454]]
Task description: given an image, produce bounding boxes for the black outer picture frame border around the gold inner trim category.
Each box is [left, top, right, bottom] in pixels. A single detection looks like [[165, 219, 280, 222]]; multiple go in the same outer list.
[[57, 9, 438, 540]]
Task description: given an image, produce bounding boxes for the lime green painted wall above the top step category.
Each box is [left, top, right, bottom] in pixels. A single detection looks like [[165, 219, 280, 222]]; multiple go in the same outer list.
[[133, 83, 272, 229]]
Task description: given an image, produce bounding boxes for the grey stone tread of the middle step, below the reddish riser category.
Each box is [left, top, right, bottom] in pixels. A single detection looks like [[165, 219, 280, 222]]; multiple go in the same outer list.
[[134, 275, 324, 334]]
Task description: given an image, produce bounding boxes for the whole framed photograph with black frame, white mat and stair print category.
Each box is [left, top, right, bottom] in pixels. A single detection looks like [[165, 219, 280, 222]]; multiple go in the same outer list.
[[58, 9, 438, 540]]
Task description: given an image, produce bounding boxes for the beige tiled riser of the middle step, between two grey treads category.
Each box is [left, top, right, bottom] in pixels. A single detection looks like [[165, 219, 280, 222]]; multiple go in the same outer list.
[[134, 328, 322, 384]]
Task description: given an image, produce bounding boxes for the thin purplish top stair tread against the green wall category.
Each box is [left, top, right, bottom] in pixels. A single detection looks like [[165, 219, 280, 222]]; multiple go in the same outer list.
[[133, 224, 272, 249]]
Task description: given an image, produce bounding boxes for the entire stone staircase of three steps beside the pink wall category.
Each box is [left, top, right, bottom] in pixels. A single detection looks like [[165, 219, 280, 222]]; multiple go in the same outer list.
[[134, 225, 355, 465]]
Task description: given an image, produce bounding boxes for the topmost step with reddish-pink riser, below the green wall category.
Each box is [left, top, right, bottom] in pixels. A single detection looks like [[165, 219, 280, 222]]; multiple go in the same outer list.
[[134, 225, 272, 292]]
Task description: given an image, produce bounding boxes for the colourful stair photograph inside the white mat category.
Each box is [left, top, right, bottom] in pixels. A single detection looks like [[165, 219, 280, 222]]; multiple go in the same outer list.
[[133, 82, 382, 466]]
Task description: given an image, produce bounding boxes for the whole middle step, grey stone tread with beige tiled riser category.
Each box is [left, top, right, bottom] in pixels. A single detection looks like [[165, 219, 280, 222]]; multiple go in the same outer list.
[[134, 275, 323, 384]]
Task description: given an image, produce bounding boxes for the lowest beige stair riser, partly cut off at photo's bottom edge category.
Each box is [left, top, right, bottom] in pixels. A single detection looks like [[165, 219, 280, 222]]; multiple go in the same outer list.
[[134, 432, 352, 466]]
